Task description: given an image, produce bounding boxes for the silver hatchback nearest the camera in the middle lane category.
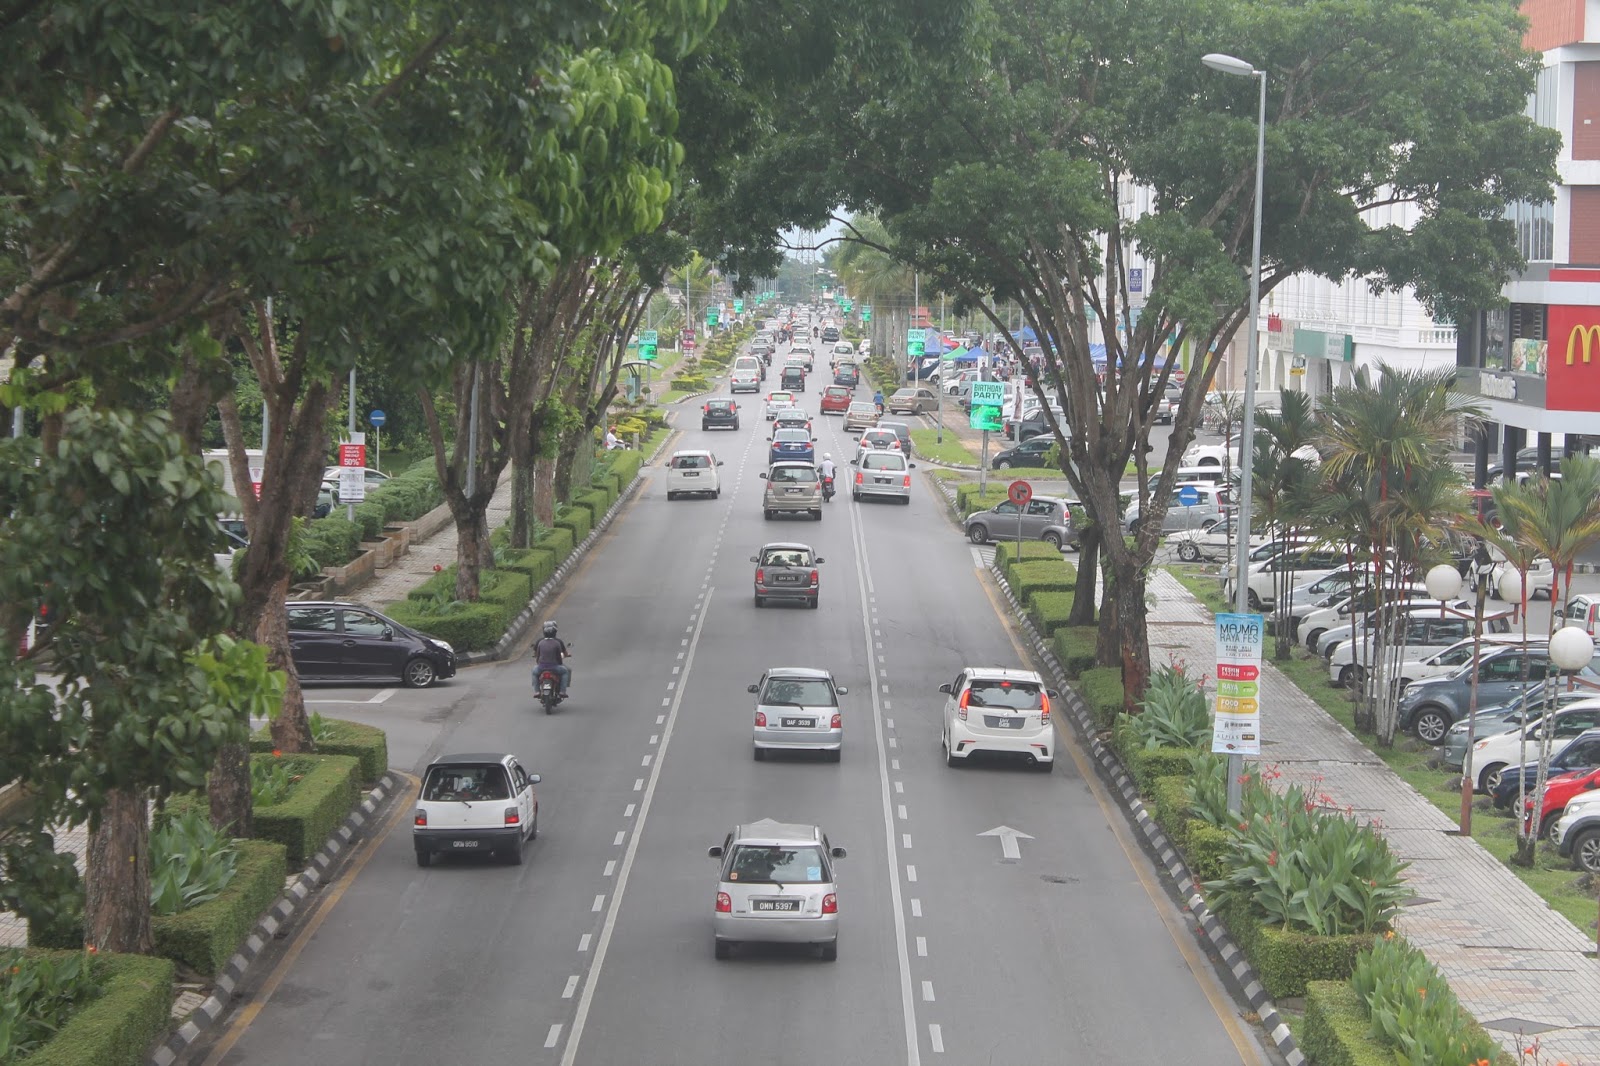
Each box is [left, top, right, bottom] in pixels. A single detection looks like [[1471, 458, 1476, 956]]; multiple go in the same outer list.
[[707, 818, 845, 962]]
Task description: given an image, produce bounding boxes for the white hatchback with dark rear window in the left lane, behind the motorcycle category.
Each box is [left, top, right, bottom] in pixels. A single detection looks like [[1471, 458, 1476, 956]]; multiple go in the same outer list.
[[411, 752, 539, 866]]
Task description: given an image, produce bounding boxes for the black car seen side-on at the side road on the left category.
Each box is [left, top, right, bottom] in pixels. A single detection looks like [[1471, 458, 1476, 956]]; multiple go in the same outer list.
[[286, 600, 456, 688]]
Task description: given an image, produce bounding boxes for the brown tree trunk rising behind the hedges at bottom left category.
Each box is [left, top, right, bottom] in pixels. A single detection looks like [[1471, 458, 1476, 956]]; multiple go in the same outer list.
[[83, 789, 155, 956]]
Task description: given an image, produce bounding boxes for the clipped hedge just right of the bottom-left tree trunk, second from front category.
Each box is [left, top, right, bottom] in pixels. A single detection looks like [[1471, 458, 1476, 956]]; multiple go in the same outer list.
[[150, 840, 288, 976]]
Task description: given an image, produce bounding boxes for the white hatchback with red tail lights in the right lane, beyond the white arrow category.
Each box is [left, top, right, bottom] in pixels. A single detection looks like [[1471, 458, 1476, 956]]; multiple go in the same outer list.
[[939, 666, 1056, 773]]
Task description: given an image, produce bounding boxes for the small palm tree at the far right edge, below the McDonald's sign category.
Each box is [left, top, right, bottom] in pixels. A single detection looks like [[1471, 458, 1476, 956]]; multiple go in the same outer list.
[[1496, 456, 1600, 866]]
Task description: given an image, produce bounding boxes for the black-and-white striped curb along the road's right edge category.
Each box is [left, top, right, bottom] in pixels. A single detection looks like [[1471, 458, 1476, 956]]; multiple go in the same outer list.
[[990, 563, 1306, 1066]]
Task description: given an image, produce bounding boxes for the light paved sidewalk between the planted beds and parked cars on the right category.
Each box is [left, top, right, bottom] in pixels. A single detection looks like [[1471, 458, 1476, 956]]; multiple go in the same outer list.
[[1149, 570, 1600, 1066]]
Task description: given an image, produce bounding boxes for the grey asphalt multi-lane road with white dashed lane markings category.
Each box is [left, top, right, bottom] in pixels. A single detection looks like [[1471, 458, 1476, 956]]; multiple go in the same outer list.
[[189, 336, 1270, 1066]]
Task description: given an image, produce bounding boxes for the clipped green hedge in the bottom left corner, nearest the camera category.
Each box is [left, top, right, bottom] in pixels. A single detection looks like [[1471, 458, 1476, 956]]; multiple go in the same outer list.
[[26, 947, 173, 1066]]
